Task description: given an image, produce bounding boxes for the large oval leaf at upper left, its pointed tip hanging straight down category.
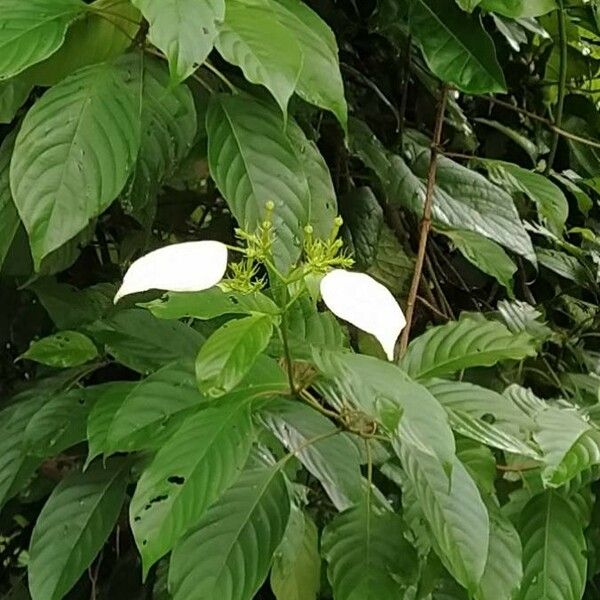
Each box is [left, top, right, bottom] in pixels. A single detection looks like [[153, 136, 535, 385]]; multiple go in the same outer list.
[[10, 63, 140, 269]]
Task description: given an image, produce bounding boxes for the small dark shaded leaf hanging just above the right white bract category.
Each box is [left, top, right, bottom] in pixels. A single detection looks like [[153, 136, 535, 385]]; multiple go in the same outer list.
[[340, 186, 383, 269]]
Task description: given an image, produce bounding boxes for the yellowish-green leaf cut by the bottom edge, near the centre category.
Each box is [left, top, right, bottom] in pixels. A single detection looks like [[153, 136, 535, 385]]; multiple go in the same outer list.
[[271, 505, 321, 600]]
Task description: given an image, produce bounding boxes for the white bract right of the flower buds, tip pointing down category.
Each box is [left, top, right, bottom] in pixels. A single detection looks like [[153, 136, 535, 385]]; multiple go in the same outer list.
[[321, 269, 406, 360]]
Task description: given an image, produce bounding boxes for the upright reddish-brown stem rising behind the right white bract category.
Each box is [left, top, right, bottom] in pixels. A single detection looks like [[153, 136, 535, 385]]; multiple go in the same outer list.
[[400, 86, 448, 356]]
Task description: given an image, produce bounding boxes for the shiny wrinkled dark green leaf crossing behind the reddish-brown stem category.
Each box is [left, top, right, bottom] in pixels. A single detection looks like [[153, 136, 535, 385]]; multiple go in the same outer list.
[[350, 120, 536, 264]]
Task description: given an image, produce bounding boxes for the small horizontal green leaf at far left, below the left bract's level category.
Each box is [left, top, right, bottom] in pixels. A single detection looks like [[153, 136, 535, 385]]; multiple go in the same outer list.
[[20, 330, 98, 368]]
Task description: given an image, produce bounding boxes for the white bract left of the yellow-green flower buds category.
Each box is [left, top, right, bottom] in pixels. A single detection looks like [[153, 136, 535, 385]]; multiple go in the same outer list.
[[115, 240, 227, 303]]
